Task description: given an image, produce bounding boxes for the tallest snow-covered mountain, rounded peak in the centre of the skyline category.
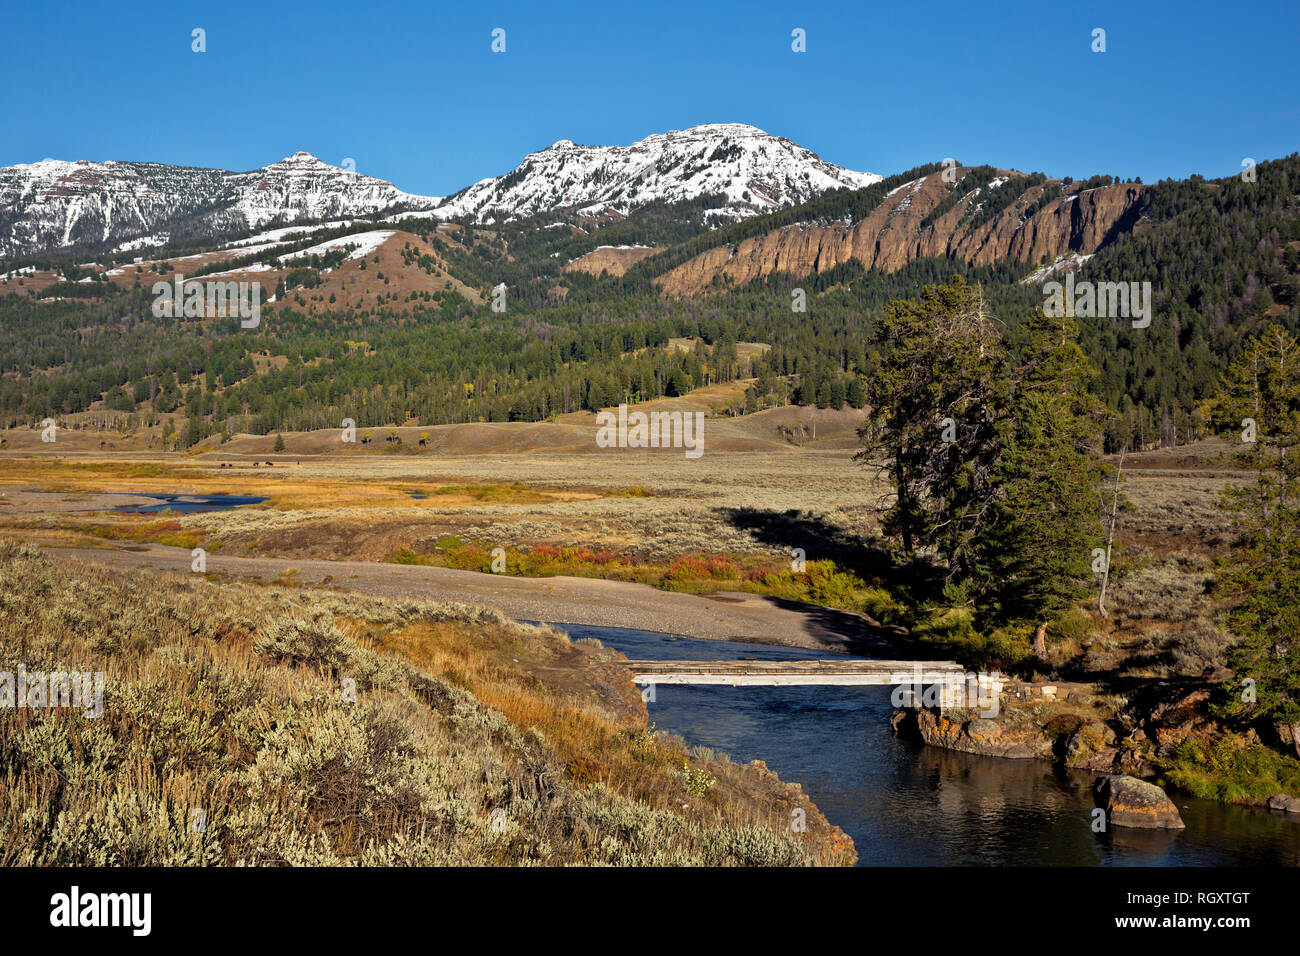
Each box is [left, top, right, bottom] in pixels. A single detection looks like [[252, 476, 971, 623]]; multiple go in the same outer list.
[[437, 124, 881, 222]]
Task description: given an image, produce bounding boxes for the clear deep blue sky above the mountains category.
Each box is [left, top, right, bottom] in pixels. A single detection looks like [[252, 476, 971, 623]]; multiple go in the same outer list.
[[0, 0, 1300, 195]]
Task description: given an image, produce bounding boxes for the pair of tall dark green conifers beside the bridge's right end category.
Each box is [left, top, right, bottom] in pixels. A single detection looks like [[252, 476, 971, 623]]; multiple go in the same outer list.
[[861, 278, 1104, 639]]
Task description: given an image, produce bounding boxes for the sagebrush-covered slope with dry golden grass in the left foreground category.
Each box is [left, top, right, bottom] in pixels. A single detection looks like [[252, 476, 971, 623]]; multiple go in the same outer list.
[[0, 540, 853, 866]]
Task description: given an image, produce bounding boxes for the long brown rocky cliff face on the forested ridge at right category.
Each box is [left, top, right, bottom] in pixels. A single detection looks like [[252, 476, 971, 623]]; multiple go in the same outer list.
[[657, 168, 1143, 295]]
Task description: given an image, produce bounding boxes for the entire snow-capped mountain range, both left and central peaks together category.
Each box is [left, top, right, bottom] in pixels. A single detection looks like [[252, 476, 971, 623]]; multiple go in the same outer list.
[[0, 124, 881, 258]]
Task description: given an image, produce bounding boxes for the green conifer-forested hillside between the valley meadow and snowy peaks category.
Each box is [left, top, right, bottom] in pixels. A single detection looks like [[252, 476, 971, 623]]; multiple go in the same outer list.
[[0, 155, 1300, 447]]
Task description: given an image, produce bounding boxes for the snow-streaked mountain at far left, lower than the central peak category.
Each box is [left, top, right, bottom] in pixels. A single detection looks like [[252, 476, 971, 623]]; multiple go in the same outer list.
[[0, 152, 441, 256]]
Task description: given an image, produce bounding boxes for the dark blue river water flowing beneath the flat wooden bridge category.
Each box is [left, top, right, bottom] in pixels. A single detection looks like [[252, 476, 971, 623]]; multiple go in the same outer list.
[[558, 624, 1300, 866]]
